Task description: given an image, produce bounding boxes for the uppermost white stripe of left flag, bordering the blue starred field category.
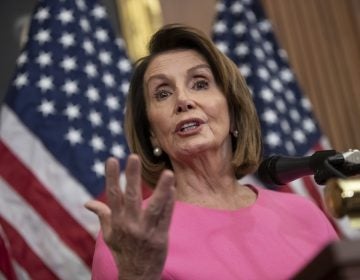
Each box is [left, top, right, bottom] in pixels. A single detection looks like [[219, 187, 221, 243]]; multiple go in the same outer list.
[[0, 105, 99, 237]]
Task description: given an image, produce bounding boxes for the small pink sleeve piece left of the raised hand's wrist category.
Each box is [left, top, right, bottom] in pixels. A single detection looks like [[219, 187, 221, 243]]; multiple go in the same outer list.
[[92, 232, 118, 280]]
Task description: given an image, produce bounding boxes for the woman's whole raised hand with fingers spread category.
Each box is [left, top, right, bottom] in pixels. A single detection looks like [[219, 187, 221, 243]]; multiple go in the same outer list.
[[85, 155, 175, 279]]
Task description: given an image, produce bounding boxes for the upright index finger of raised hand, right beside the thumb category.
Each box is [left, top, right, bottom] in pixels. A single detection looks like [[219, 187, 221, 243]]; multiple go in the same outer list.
[[105, 157, 123, 217]]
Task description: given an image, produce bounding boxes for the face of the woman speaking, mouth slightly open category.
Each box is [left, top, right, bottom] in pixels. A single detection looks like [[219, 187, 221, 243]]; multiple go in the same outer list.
[[144, 50, 231, 159]]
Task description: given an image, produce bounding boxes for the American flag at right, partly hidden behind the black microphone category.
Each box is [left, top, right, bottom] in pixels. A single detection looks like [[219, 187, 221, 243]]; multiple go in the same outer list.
[[213, 0, 358, 236]]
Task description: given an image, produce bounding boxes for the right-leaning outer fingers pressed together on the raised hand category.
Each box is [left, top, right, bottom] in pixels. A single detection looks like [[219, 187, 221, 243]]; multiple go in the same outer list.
[[144, 170, 175, 232]]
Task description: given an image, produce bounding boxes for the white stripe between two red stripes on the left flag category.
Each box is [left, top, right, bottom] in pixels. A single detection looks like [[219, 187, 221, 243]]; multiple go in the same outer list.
[[0, 178, 90, 279]]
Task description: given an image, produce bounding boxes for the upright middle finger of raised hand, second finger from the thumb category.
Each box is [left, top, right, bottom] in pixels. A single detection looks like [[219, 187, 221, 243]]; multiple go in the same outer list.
[[124, 155, 142, 219]]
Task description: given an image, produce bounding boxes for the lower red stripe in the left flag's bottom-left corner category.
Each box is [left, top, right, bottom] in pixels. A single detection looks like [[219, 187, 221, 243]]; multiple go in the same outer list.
[[0, 216, 58, 279]]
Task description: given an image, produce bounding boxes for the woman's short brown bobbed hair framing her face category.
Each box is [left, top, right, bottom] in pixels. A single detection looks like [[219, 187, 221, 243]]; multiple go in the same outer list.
[[125, 24, 262, 187]]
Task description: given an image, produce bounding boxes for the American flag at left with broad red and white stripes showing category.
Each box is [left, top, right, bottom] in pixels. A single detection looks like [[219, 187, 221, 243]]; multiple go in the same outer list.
[[0, 0, 132, 279]]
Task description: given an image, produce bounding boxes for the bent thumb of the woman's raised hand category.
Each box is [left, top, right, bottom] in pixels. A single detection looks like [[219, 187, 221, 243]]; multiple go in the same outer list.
[[84, 200, 111, 239]]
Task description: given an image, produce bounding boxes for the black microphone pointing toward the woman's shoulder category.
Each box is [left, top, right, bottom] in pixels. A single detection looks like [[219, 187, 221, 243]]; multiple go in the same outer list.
[[257, 150, 360, 185]]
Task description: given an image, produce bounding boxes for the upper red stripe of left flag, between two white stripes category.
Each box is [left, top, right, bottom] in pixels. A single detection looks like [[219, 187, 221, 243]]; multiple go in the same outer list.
[[0, 141, 95, 267]]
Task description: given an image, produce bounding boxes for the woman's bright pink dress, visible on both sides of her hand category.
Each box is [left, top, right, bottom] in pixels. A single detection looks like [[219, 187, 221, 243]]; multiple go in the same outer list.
[[92, 188, 338, 280]]
